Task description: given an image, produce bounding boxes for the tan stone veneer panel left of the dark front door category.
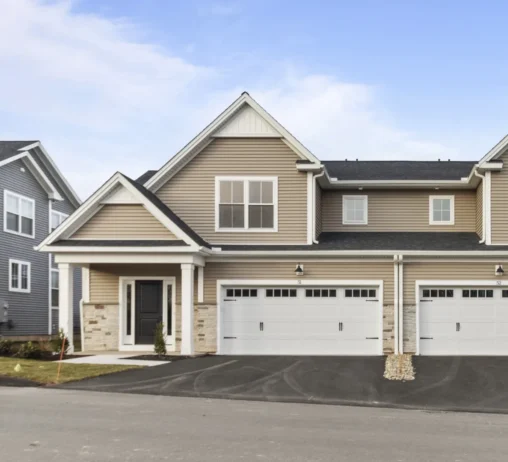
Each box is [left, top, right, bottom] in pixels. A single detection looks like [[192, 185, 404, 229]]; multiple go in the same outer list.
[[82, 303, 119, 351]]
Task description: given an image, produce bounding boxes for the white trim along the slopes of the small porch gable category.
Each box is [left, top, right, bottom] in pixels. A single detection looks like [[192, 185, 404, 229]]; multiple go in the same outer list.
[[35, 173, 201, 252]]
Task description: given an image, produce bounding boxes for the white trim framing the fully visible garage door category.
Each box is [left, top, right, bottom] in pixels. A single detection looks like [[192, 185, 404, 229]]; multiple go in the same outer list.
[[217, 279, 384, 355]]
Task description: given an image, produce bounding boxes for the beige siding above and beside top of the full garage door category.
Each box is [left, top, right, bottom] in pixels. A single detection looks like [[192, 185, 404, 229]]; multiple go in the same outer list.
[[204, 261, 394, 305]]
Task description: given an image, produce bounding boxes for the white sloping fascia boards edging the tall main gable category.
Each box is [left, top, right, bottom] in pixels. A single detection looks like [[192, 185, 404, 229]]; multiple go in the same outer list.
[[144, 93, 320, 192]]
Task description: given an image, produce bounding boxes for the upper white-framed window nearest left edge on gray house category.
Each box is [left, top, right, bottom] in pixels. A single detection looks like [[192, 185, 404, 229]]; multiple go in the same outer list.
[[4, 190, 35, 238]]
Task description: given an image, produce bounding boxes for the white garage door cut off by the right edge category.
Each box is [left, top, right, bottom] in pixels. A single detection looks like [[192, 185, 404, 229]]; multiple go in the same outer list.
[[419, 287, 508, 355]]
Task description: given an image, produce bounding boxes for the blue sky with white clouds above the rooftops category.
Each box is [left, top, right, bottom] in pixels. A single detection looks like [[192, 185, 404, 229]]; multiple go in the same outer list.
[[0, 0, 508, 198]]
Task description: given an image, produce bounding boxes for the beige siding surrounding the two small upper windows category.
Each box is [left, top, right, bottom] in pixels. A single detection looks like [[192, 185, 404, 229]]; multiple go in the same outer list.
[[322, 189, 476, 232]]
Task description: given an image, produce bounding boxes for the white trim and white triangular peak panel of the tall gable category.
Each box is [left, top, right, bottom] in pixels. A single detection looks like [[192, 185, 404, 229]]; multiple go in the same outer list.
[[145, 92, 320, 192]]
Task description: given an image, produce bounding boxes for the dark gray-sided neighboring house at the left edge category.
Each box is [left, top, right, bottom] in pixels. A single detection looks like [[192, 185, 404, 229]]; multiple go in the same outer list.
[[0, 141, 81, 339]]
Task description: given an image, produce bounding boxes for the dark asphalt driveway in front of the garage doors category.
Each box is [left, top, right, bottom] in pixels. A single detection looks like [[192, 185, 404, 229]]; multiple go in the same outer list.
[[61, 356, 508, 413]]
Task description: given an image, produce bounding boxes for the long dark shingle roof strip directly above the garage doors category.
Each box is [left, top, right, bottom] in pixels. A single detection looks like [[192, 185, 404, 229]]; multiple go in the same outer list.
[[217, 232, 508, 252]]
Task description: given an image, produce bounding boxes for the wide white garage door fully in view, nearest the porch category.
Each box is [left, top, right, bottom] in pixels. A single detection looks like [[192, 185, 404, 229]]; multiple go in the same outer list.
[[220, 286, 382, 355]]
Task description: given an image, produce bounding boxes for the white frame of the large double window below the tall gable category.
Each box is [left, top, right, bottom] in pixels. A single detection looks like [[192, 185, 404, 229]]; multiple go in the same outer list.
[[215, 176, 279, 233]]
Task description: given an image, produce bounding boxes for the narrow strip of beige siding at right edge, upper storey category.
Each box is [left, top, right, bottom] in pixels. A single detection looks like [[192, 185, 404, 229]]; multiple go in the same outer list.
[[491, 154, 508, 244]]
